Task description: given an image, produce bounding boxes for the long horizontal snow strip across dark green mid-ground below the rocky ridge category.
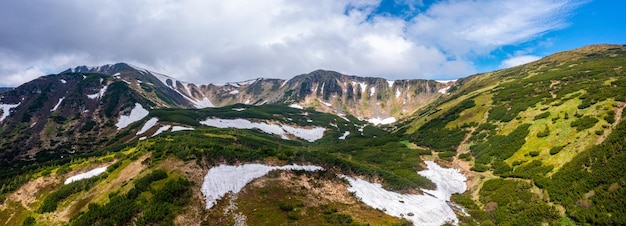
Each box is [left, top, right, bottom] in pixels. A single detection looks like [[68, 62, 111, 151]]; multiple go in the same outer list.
[[200, 118, 326, 142]]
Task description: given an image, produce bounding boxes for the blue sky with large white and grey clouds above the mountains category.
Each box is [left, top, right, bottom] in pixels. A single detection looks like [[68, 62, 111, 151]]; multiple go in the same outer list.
[[0, 0, 626, 87]]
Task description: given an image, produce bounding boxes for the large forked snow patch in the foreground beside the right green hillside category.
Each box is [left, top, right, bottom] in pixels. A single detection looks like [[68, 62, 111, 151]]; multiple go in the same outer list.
[[344, 161, 467, 225]]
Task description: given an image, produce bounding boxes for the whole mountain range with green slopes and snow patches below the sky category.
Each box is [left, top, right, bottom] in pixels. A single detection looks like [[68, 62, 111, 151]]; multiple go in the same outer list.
[[0, 45, 626, 225]]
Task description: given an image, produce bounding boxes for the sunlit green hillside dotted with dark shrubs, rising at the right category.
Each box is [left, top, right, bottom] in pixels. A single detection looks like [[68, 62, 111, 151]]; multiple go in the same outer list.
[[398, 45, 626, 225]]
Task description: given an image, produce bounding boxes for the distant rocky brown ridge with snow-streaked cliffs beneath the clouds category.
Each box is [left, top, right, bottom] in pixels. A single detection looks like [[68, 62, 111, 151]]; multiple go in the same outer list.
[[64, 63, 454, 118]]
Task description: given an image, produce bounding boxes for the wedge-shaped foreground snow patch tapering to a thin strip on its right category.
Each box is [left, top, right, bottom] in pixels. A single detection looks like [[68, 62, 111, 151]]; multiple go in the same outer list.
[[201, 164, 323, 209]]
